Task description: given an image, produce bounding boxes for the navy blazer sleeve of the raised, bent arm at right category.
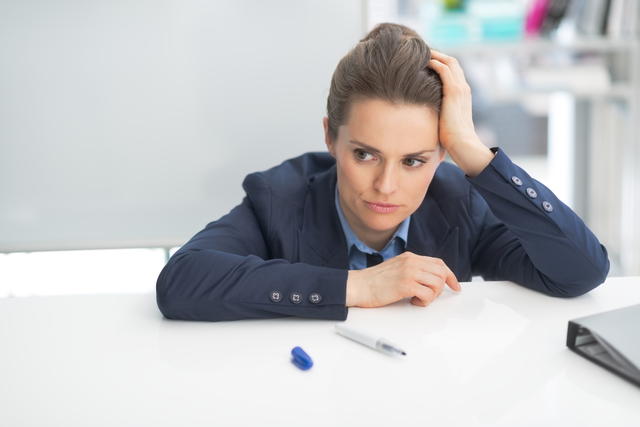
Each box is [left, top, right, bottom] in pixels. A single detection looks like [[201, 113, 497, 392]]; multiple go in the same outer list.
[[467, 149, 609, 297]]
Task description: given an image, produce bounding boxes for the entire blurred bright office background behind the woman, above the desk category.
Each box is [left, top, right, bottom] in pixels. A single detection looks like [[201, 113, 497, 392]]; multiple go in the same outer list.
[[0, 0, 640, 297]]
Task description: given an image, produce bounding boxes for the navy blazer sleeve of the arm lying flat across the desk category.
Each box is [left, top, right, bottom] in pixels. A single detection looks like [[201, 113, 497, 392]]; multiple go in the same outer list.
[[156, 174, 348, 321]]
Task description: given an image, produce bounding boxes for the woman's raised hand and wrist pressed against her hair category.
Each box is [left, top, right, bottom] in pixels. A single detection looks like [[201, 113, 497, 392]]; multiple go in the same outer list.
[[429, 50, 493, 178]]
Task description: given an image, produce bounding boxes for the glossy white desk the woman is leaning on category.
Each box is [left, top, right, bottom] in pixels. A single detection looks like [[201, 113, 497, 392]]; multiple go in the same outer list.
[[0, 277, 640, 427]]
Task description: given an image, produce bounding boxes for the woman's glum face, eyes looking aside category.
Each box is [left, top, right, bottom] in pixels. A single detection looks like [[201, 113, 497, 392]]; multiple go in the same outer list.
[[324, 100, 445, 250]]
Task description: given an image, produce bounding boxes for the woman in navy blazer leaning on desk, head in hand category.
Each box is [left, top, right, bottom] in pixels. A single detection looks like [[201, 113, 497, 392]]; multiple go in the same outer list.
[[157, 24, 609, 320]]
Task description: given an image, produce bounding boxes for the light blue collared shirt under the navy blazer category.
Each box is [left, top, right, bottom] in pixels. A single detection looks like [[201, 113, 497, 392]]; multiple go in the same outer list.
[[336, 186, 411, 270]]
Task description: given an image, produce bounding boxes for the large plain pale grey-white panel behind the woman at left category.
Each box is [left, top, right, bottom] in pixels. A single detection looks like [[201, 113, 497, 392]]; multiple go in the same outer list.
[[0, 0, 363, 252]]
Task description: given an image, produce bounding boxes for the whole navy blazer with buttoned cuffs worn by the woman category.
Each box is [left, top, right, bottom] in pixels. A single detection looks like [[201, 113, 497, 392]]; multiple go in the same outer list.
[[157, 149, 609, 320]]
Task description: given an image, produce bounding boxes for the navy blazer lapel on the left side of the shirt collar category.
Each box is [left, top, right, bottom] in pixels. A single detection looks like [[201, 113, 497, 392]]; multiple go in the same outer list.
[[299, 165, 349, 270]]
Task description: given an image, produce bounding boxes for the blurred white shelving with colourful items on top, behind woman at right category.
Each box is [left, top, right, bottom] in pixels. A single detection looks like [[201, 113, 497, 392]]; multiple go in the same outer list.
[[364, 0, 640, 276]]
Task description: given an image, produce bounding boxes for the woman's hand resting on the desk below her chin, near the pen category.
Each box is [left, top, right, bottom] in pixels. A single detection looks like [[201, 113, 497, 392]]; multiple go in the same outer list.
[[346, 252, 462, 307]]
